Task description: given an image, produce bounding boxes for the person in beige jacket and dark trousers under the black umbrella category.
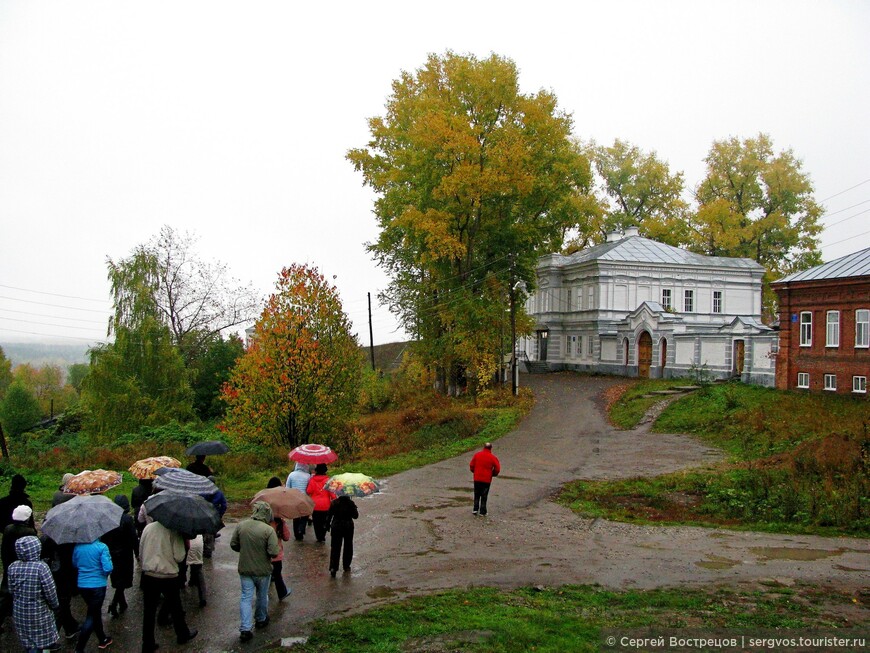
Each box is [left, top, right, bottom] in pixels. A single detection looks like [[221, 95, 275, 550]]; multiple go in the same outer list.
[[139, 521, 198, 653]]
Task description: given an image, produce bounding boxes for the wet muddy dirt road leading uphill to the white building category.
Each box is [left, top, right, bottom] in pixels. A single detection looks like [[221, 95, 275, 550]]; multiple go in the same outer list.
[[0, 374, 870, 651]]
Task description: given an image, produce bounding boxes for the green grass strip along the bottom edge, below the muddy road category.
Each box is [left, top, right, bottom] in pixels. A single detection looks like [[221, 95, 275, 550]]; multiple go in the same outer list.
[[270, 586, 868, 653]]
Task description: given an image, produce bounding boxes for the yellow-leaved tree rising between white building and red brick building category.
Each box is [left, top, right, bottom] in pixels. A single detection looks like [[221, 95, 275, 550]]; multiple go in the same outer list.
[[688, 134, 822, 316]]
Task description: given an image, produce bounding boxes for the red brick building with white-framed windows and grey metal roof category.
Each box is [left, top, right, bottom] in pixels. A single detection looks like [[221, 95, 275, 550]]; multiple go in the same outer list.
[[772, 248, 870, 397]]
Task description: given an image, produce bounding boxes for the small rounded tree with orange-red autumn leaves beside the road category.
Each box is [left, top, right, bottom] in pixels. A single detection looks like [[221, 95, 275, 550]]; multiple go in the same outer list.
[[223, 264, 362, 447]]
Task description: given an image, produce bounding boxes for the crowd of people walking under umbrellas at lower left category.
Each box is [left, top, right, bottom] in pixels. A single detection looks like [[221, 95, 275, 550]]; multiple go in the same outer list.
[[0, 456, 359, 653]]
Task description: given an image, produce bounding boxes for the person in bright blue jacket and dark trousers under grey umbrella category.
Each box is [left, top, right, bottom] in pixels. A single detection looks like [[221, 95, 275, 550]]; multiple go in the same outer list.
[[73, 540, 112, 653]]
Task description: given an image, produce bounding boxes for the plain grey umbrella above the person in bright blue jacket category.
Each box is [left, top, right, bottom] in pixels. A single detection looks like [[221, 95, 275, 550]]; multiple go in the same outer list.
[[42, 495, 124, 544]]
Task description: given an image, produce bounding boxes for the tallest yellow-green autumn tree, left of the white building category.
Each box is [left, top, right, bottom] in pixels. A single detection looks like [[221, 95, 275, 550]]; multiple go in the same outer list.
[[347, 52, 591, 390]]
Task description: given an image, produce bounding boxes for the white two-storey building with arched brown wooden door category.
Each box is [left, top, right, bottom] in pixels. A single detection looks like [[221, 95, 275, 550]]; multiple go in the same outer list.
[[518, 228, 777, 386]]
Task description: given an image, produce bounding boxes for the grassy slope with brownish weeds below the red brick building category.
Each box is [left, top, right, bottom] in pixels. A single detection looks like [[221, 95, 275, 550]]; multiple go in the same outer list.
[[558, 382, 870, 537]]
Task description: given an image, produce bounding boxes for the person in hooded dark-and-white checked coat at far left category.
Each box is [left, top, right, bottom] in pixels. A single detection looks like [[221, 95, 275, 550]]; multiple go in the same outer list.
[[9, 535, 60, 653]]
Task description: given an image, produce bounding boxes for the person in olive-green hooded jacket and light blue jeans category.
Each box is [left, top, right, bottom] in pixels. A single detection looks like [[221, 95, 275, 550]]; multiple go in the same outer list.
[[230, 501, 279, 642]]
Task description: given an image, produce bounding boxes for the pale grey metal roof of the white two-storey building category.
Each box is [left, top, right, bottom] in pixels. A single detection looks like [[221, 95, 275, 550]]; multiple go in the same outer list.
[[558, 236, 763, 270]]
